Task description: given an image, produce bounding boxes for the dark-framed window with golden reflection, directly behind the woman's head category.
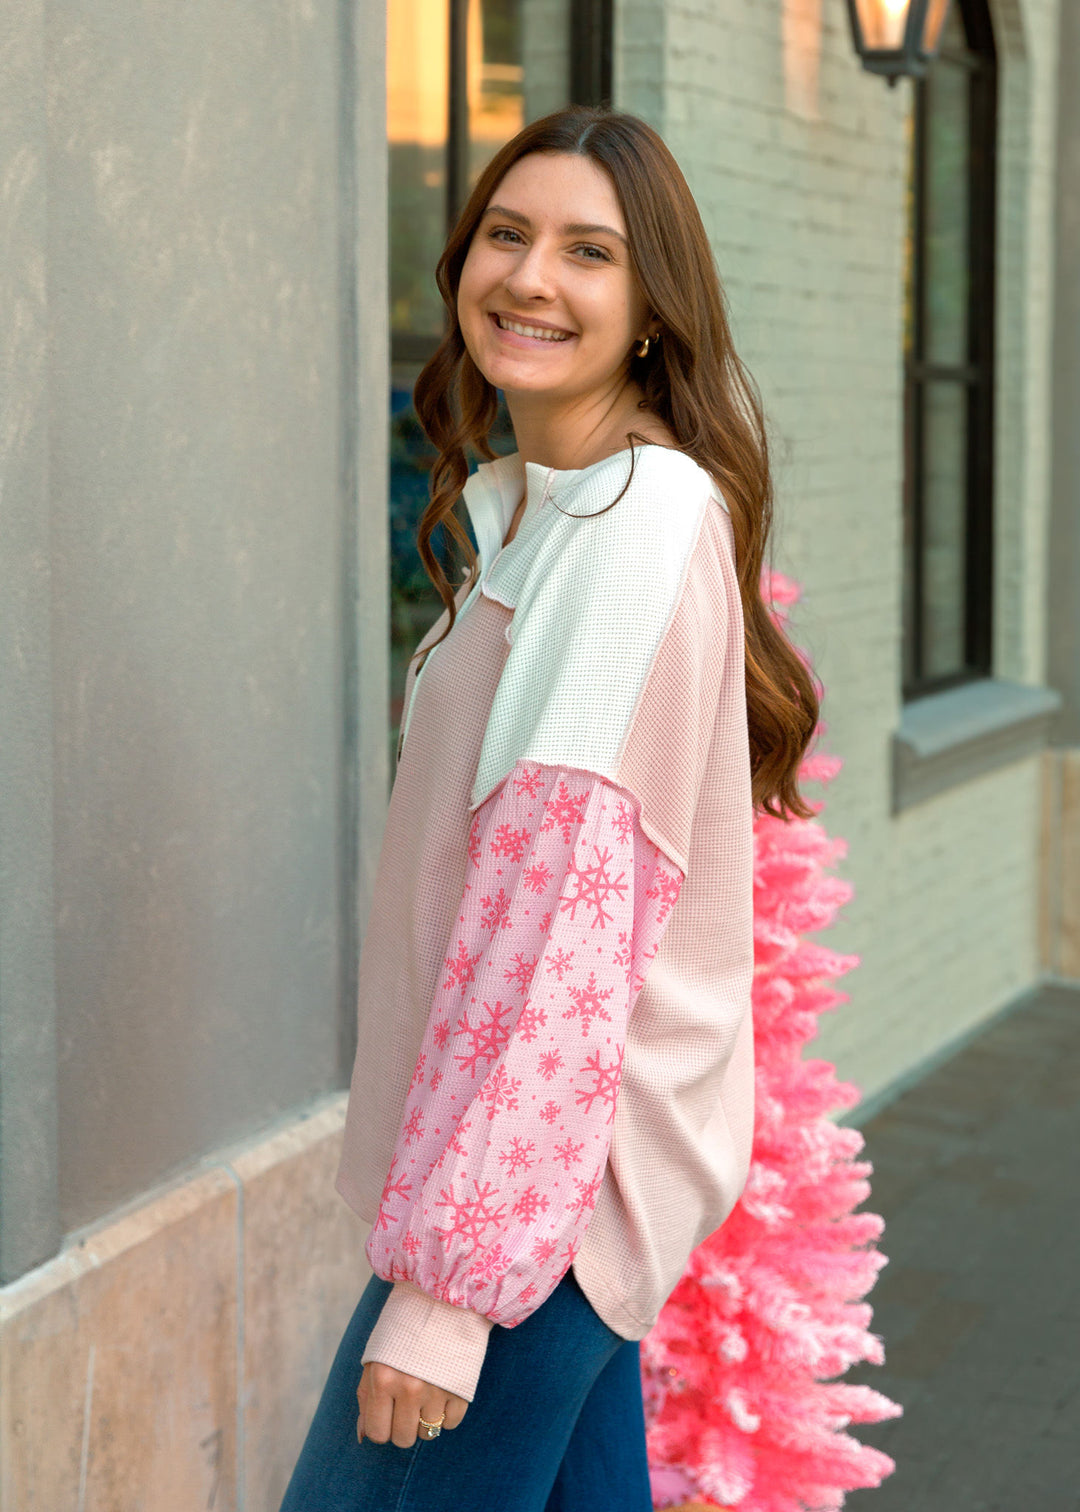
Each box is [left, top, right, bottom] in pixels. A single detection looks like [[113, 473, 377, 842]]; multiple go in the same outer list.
[[387, 0, 613, 739]]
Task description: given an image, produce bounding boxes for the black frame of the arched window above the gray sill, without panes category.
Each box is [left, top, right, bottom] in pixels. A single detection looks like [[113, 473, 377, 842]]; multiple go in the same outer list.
[[903, 0, 997, 700]]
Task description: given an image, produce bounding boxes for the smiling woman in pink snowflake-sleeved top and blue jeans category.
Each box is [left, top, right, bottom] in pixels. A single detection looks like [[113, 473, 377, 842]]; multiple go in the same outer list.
[[283, 107, 817, 1512]]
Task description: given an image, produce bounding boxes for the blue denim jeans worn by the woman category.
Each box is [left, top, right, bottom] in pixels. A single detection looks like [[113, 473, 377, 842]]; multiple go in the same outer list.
[[280, 1267, 652, 1512]]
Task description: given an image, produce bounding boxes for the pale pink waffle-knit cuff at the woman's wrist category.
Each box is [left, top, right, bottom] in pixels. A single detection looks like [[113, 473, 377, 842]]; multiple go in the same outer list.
[[360, 1281, 492, 1402]]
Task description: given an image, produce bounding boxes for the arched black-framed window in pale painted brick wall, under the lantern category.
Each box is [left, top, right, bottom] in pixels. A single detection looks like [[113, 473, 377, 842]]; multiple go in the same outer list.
[[903, 0, 997, 699]]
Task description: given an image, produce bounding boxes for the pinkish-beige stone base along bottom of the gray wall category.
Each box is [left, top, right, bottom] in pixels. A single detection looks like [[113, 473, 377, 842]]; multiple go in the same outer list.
[[0, 1092, 361, 1512]]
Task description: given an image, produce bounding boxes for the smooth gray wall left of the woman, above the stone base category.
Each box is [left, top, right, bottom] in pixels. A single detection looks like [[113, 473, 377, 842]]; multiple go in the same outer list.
[[0, 0, 387, 1279]]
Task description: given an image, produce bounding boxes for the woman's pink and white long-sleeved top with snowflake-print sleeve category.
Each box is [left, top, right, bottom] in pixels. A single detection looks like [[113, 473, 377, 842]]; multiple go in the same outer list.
[[334, 445, 756, 1397]]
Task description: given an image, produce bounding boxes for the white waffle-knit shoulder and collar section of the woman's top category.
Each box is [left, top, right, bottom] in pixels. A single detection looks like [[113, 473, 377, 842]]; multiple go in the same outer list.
[[470, 446, 728, 807]]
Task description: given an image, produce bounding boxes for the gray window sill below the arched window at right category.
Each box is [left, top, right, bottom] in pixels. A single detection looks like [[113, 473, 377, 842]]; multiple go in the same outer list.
[[892, 677, 1062, 813]]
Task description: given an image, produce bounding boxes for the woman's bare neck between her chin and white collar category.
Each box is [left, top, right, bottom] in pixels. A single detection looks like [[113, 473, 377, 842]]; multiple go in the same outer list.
[[505, 368, 659, 469]]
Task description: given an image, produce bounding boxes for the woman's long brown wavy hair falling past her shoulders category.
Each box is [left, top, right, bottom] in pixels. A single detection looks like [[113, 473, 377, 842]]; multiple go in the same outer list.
[[413, 106, 818, 818]]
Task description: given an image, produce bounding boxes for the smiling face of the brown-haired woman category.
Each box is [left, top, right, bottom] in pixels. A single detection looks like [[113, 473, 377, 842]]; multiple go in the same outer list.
[[457, 153, 655, 402]]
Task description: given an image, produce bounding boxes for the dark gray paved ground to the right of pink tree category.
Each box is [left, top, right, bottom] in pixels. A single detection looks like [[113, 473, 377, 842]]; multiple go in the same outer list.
[[844, 987, 1080, 1512]]
